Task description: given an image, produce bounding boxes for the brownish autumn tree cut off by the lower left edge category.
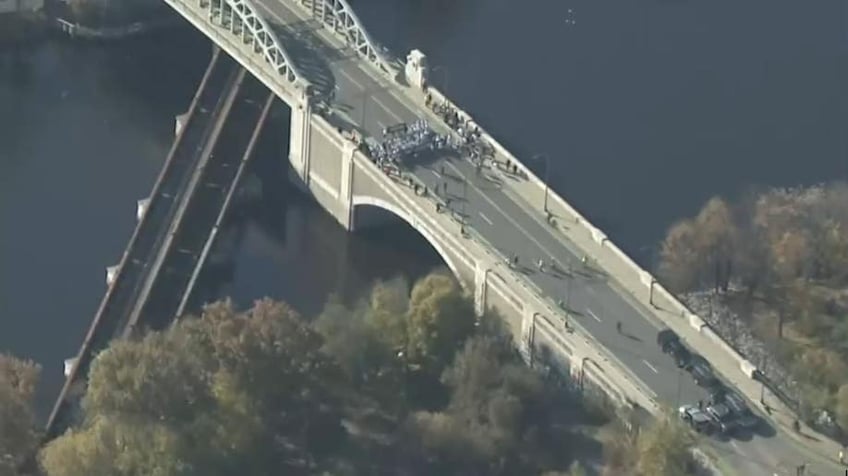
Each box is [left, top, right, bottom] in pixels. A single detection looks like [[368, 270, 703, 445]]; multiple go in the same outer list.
[[0, 354, 40, 475]]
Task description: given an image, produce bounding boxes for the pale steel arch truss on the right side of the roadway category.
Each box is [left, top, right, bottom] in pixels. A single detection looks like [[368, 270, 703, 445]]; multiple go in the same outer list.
[[298, 0, 395, 73]]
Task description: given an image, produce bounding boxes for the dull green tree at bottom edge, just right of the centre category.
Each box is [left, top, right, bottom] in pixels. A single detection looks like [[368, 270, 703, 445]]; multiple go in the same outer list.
[[410, 336, 562, 474]]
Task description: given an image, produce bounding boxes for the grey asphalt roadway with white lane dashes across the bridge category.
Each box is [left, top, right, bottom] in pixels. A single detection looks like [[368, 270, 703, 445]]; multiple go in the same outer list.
[[250, 0, 830, 476]]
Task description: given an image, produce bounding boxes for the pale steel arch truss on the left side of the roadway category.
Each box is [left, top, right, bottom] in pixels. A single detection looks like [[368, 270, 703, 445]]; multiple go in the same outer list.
[[199, 0, 309, 86]]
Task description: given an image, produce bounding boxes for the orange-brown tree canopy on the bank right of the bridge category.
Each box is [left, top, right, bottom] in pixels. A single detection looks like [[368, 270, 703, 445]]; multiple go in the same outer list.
[[657, 182, 848, 437]]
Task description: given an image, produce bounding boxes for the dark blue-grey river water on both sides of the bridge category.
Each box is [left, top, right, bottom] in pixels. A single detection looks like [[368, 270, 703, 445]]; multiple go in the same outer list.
[[0, 0, 848, 407]]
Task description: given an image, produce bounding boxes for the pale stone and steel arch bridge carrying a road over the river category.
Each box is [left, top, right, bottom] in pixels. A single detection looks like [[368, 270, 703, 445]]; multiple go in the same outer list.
[[61, 0, 800, 472]]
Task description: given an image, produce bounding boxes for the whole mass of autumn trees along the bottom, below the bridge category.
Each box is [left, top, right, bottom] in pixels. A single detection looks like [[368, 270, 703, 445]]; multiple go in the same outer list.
[[28, 274, 704, 476]]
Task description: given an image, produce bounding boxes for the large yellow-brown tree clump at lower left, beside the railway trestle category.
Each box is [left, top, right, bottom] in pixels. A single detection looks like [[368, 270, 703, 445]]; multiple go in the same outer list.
[[40, 300, 340, 476]]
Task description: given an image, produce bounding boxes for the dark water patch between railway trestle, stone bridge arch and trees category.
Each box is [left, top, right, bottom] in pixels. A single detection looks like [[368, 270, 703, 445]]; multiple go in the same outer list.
[[191, 112, 444, 316]]
